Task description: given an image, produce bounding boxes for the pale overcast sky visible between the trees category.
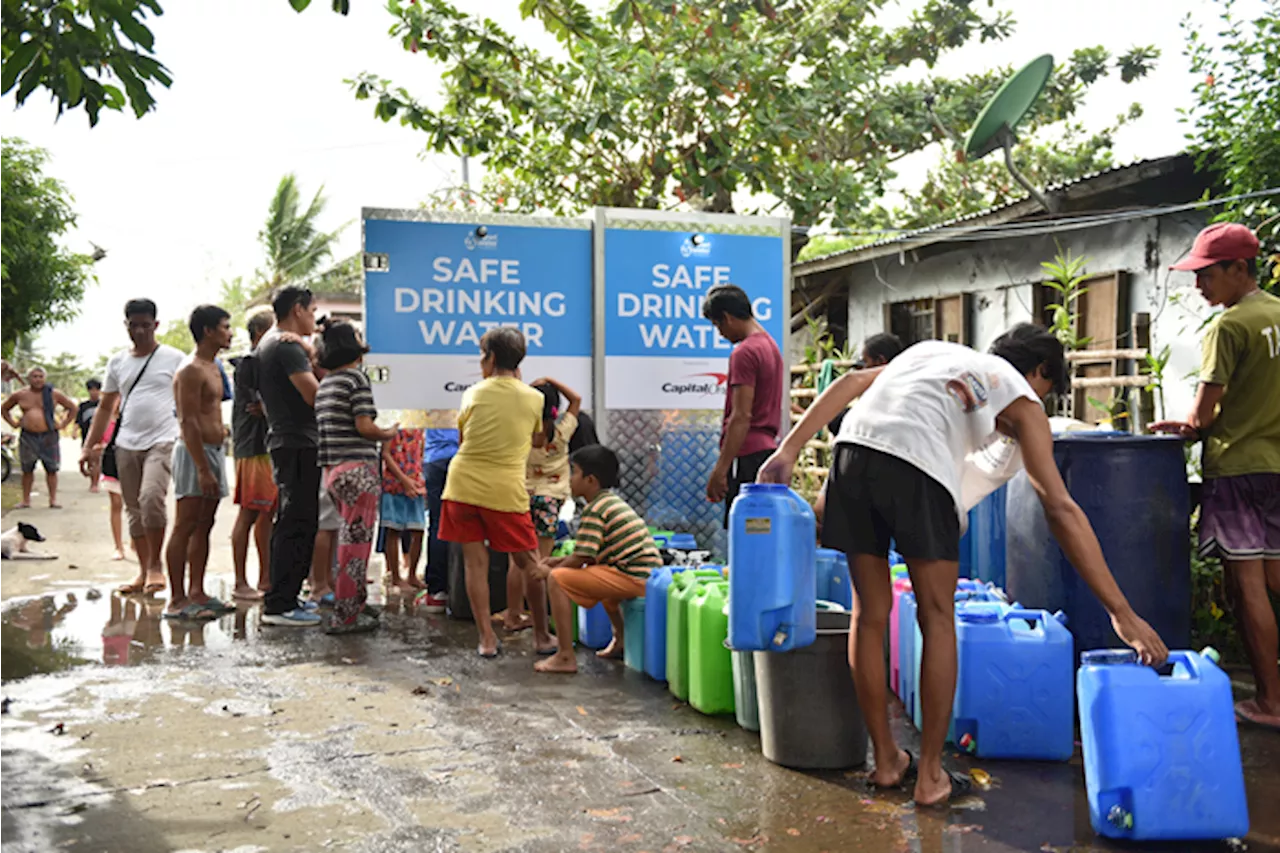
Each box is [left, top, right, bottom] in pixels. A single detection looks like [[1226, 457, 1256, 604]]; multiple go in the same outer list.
[[0, 0, 1228, 364]]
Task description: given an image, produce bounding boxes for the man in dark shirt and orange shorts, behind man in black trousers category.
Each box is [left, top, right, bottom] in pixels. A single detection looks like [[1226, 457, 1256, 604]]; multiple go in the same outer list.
[[232, 311, 278, 601]]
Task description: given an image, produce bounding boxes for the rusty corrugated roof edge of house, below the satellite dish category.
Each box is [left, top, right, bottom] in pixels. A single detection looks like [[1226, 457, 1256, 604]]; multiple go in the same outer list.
[[791, 152, 1192, 279]]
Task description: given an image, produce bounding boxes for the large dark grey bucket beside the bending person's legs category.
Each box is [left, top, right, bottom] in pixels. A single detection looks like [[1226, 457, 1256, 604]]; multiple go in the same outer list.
[[735, 610, 867, 770]]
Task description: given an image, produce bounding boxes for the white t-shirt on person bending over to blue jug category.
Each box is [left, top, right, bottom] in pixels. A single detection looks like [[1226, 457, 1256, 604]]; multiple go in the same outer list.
[[836, 341, 1041, 529]]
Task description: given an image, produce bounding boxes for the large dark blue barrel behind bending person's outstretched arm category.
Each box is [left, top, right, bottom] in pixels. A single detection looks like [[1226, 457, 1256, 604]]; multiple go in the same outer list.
[[1007, 433, 1192, 660]]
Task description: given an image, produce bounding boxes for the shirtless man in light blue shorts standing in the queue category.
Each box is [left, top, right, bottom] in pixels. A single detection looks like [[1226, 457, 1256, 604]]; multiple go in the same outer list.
[[164, 305, 234, 620]]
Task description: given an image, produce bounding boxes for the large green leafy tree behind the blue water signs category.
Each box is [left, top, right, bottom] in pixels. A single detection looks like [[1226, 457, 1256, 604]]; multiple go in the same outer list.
[[352, 0, 1155, 235]]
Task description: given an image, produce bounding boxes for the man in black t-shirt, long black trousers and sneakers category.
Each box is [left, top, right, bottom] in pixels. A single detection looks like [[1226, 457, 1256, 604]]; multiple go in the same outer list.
[[257, 284, 320, 628]]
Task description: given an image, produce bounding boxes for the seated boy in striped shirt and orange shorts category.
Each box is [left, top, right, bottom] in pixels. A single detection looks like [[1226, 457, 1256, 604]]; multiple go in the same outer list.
[[534, 444, 662, 672]]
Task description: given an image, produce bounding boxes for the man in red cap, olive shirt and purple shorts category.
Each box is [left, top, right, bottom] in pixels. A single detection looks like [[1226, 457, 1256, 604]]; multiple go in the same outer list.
[[1152, 223, 1280, 730]]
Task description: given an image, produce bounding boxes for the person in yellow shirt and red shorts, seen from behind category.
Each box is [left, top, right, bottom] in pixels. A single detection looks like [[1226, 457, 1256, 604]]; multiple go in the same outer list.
[[440, 327, 556, 658]]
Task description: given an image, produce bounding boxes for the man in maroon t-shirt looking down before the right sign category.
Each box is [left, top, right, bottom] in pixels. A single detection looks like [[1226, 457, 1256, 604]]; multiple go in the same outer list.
[[703, 284, 786, 528]]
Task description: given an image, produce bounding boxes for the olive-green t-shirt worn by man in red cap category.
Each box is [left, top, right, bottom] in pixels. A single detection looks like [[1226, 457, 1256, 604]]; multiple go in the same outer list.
[[1201, 291, 1280, 478]]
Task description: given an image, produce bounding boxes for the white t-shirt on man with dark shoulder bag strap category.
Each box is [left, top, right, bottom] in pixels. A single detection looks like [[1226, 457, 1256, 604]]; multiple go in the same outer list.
[[102, 343, 187, 451]]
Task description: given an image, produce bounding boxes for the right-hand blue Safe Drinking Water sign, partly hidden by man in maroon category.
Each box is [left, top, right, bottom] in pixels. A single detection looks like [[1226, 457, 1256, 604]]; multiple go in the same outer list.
[[604, 224, 787, 410]]
